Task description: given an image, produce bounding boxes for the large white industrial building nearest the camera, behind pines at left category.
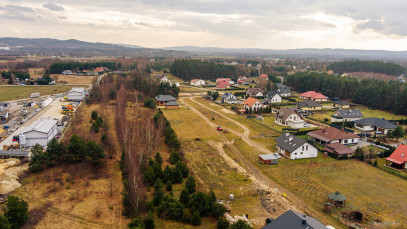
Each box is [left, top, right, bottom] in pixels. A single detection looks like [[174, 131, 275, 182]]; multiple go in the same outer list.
[[19, 119, 58, 147]]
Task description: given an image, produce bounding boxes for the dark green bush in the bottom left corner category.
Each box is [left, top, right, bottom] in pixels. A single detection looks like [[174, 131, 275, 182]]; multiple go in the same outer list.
[[4, 196, 28, 228]]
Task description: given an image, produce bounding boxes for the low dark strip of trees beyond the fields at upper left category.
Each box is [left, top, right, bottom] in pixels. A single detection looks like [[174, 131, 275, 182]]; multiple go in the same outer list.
[[49, 62, 116, 74]]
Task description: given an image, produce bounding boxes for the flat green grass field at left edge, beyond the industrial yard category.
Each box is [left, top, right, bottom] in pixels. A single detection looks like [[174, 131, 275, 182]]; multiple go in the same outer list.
[[0, 85, 79, 101]]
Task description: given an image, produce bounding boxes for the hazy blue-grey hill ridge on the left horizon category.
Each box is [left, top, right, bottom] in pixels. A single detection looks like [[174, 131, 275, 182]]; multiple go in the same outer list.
[[0, 37, 186, 57]]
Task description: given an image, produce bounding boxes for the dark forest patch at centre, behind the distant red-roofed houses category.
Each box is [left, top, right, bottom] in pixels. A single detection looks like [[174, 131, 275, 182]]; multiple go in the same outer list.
[[170, 59, 243, 81]]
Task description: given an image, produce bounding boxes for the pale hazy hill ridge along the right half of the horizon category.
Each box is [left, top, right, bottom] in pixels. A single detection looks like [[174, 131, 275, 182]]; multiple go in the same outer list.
[[163, 46, 407, 61]]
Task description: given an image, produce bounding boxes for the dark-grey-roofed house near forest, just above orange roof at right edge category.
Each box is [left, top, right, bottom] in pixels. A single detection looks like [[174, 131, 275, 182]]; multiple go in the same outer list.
[[355, 118, 397, 134]]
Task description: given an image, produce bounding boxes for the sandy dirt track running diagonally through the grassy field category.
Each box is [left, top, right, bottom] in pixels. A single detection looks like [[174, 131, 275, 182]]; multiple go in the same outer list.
[[180, 98, 343, 228]]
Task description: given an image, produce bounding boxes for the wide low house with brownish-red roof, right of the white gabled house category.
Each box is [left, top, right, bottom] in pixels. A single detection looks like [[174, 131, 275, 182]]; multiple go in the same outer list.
[[307, 127, 359, 145]]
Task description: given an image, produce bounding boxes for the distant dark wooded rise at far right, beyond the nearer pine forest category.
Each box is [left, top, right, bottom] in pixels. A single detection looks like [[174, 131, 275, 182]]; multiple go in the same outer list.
[[327, 60, 406, 76]]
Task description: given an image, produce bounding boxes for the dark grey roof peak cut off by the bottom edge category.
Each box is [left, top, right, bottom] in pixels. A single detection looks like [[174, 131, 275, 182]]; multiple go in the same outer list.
[[262, 210, 327, 229]]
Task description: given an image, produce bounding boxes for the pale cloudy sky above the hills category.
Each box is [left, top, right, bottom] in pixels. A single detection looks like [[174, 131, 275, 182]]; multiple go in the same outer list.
[[0, 0, 407, 51]]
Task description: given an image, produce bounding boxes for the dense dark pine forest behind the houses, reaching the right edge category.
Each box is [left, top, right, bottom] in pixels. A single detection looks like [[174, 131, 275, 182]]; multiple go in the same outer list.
[[285, 72, 407, 115]]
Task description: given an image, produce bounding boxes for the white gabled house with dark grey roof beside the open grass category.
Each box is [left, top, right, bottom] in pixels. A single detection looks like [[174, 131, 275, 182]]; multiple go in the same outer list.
[[275, 133, 318, 160]]
